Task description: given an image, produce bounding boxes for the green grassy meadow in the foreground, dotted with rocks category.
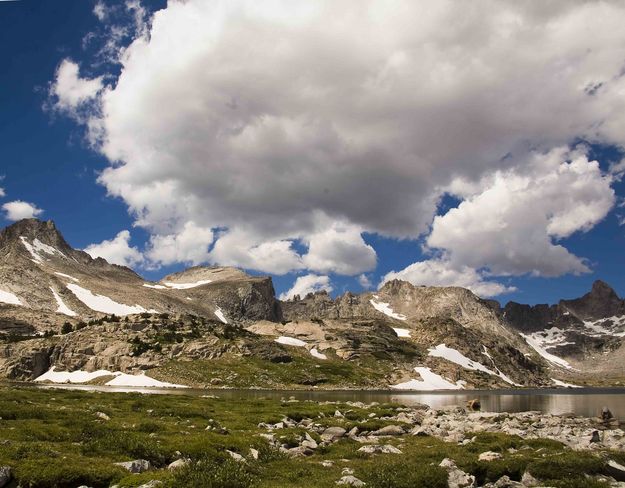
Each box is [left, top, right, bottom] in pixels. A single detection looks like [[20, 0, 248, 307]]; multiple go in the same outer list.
[[0, 386, 624, 488]]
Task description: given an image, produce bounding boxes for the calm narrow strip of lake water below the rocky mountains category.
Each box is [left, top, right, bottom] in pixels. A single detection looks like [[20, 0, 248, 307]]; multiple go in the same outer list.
[[18, 383, 625, 419]]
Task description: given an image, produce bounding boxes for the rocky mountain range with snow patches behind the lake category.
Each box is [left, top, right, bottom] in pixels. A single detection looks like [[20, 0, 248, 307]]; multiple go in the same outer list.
[[0, 219, 625, 390]]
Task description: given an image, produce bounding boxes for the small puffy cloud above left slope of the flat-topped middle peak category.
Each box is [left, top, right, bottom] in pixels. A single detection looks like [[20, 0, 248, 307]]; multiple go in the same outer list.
[[146, 222, 213, 265]]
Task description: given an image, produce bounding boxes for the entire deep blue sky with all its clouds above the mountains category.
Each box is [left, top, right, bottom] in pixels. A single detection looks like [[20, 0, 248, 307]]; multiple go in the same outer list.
[[0, 0, 625, 304]]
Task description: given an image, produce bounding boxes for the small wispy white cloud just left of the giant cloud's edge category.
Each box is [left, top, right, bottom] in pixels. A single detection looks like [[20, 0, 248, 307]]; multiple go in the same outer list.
[[50, 59, 103, 114]]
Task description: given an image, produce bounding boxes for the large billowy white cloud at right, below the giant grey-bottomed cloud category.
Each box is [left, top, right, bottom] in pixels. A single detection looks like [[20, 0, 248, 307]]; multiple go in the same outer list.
[[426, 147, 615, 276]]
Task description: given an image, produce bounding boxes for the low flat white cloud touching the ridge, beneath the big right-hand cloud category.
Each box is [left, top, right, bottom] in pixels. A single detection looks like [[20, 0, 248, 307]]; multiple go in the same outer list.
[[381, 259, 515, 297]]
